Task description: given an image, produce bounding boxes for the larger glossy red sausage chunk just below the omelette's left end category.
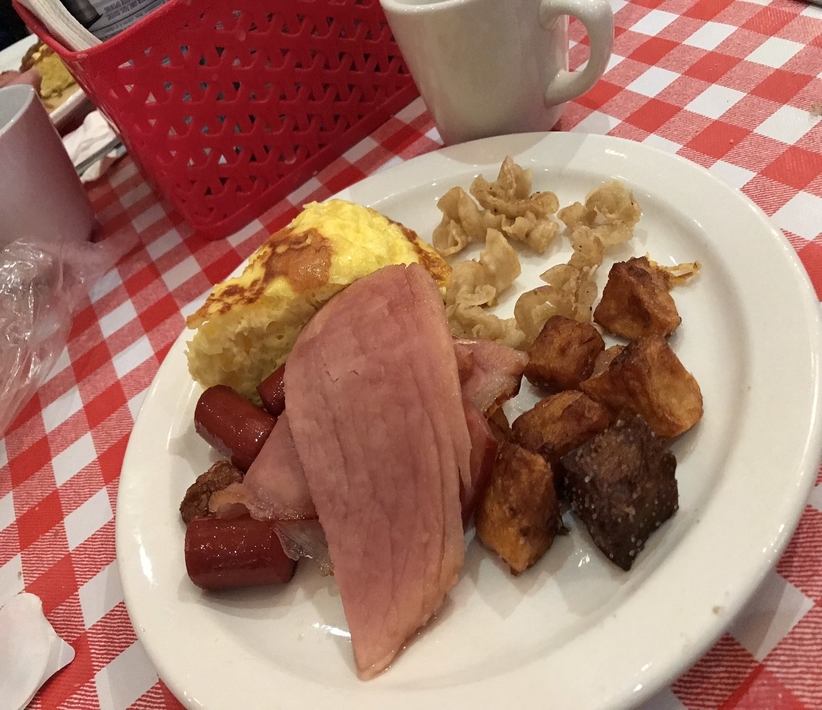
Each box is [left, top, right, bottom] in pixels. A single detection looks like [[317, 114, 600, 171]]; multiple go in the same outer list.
[[194, 385, 277, 471]]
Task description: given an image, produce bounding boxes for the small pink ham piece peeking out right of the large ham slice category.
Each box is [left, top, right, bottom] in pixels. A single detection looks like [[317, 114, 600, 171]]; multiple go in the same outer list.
[[454, 339, 528, 416]]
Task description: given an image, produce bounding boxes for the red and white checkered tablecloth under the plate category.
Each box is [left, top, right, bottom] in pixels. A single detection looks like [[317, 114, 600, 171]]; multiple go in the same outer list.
[[0, 0, 822, 710]]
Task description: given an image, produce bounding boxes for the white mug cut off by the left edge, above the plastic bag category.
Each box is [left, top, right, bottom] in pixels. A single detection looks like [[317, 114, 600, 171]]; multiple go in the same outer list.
[[0, 84, 94, 247]]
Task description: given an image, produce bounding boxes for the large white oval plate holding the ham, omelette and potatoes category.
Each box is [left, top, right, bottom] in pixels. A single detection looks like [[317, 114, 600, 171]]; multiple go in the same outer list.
[[116, 133, 822, 710]]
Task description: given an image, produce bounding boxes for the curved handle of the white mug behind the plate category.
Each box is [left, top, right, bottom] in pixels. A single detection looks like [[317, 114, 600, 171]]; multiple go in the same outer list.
[[539, 0, 614, 106]]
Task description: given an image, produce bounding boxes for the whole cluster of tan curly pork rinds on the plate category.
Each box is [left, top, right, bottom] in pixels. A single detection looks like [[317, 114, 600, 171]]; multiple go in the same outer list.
[[433, 165, 652, 349]]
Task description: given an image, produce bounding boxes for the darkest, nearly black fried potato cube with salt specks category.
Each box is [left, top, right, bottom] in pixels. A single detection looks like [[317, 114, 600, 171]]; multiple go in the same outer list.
[[562, 415, 679, 570]]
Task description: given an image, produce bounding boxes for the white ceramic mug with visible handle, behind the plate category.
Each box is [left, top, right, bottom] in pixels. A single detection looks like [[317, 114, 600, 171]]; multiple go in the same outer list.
[[380, 0, 614, 144]]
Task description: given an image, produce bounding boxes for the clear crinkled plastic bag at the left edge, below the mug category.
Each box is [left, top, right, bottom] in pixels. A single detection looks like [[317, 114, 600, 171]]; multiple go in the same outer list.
[[0, 239, 116, 437]]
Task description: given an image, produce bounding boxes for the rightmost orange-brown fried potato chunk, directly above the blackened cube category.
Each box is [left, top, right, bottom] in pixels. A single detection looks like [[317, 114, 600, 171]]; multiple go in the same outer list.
[[580, 335, 703, 439]]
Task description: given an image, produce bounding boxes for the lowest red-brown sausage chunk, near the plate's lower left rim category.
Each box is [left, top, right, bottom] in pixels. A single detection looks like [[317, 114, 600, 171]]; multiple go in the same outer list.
[[185, 517, 297, 589]]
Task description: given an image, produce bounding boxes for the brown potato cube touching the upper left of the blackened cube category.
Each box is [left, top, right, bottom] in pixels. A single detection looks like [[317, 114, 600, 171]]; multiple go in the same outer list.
[[511, 390, 611, 464]]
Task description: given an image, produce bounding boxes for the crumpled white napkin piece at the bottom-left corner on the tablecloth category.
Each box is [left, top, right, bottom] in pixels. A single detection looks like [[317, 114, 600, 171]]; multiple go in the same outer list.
[[0, 592, 74, 710]]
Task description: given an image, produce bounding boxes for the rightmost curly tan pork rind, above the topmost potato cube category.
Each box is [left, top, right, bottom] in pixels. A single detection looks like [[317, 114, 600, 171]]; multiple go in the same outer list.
[[557, 180, 642, 247]]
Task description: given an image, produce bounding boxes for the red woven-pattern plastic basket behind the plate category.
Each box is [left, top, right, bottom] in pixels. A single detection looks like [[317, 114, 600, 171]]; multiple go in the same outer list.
[[15, 0, 418, 238]]
